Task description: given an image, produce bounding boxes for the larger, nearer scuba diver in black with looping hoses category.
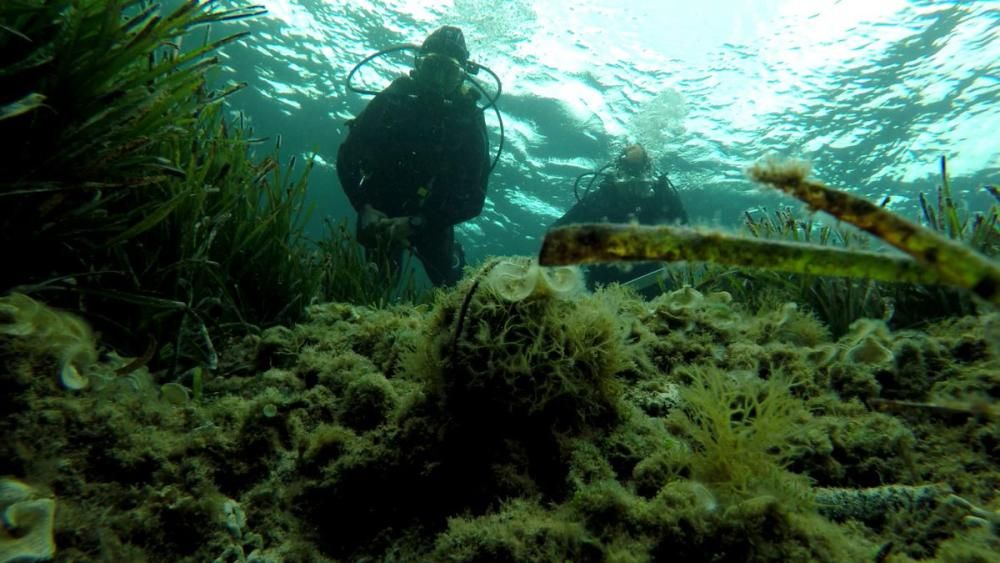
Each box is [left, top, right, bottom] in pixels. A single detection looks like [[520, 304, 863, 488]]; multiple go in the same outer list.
[[337, 26, 503, 286]]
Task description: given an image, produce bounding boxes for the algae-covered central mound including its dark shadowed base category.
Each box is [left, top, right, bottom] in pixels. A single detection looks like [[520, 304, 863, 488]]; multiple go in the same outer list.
[[292, 259, 646, 540]]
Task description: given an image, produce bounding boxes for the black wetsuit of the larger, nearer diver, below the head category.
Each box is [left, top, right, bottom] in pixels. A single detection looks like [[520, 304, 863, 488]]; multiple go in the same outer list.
[[337, 77, 490, 285]]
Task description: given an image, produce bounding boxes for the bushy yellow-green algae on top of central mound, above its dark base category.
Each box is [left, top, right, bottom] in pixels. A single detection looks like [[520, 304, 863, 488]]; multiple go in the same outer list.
[[411, 258, 633, 429]]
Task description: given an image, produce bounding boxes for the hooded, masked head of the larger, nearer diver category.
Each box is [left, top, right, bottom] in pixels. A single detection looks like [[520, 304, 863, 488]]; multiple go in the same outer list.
[[413, 25, 469, 95]]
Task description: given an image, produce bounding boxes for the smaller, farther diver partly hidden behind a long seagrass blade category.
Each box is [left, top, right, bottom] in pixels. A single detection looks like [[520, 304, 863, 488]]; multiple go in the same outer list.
[[552, 143, 688, 296]]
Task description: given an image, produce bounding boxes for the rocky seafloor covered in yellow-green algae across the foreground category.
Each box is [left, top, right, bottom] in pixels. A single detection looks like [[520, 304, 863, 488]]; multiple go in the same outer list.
[[0, 267, 1000, 562]]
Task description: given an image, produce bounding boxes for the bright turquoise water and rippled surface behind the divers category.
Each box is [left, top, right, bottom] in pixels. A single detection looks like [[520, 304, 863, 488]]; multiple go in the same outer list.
[[213, 0, 1000, 261]]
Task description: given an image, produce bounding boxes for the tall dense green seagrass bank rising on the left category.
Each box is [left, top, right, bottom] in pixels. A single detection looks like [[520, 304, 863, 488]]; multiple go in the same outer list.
[[0, 0, 412, 367]]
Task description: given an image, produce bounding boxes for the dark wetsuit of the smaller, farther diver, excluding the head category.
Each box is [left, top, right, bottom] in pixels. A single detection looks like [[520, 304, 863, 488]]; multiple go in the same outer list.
[[552, 175, 688, 289]]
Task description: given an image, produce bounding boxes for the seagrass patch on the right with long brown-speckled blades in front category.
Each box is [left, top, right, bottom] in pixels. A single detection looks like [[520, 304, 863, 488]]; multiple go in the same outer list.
[[542, 158, 1000, 335]]
